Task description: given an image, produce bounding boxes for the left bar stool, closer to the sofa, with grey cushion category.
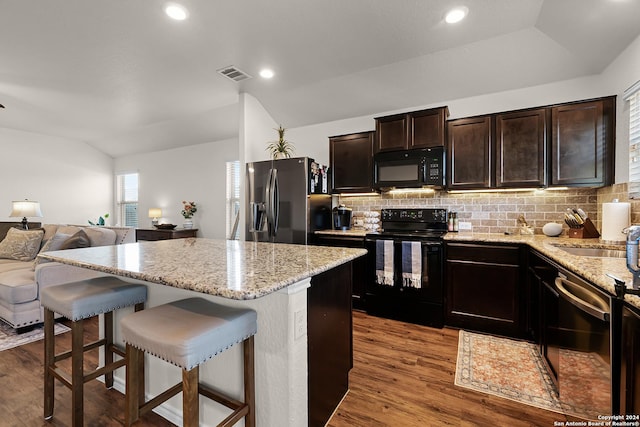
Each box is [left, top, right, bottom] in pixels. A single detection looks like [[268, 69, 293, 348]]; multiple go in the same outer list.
[[40, 277, 147, 426]]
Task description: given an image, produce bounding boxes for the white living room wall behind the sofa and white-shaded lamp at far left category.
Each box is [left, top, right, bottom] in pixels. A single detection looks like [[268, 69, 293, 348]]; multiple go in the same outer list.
[[0, 128, 113, 224]]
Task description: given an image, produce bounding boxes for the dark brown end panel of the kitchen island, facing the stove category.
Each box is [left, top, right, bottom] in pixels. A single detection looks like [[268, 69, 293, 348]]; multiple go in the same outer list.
[[307, 262, 353, 427]]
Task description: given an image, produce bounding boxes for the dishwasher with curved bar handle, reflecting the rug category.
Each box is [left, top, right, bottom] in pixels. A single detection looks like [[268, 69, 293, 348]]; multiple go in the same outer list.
[[555, 271, 613, 419]]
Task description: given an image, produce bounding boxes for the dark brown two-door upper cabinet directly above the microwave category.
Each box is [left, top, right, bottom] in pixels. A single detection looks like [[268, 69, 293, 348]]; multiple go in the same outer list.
[[374, 107, 449, 153]]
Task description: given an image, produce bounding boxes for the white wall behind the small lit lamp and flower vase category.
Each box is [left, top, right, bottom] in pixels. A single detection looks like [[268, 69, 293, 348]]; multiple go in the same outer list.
[[114, 139, 238, 239]]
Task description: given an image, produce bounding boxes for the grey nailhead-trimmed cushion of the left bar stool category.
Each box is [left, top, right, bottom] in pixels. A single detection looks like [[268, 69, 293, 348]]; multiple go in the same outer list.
[[40, 276, 147, 322]]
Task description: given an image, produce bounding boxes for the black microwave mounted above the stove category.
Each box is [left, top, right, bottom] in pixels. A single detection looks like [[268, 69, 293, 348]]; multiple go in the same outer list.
[[373, 147, 445, 189]]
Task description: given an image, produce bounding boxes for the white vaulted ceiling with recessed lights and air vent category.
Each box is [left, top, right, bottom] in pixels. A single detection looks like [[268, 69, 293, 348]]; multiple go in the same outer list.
[[0, 0, 640, 157]]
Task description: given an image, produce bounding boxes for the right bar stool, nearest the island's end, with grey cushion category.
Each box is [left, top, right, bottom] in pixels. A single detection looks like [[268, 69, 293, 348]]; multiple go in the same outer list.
[[120, 298, 257, 427]]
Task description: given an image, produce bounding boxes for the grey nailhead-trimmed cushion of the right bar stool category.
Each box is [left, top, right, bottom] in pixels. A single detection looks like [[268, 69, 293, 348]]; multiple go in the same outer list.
[[120, 298, 258, 371]]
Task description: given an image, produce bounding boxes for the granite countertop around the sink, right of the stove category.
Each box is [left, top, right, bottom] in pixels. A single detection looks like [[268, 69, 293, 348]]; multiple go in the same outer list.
[[444, 232, 640, 308]]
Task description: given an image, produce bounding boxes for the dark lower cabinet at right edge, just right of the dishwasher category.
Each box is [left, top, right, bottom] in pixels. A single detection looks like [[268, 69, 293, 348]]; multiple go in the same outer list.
[[620, 305, 640, 414]]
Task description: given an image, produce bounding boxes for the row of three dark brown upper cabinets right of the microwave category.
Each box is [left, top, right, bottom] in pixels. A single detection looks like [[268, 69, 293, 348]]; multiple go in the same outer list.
[[447, 96, 615, 190]]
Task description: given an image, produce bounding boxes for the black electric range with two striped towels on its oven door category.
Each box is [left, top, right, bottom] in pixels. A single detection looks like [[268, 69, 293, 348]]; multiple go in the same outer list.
[[364, 209, 447, 328]]
